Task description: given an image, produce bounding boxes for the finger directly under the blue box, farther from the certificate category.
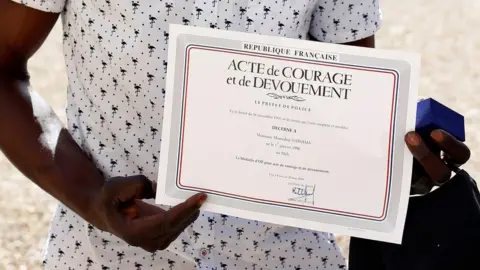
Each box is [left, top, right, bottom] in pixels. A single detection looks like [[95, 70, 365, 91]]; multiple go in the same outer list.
[[430, 129, 470, 165]]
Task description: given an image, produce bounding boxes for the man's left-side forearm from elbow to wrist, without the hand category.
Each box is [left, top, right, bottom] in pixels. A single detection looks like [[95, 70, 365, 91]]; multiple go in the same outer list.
[[0, 73, 104, 226]]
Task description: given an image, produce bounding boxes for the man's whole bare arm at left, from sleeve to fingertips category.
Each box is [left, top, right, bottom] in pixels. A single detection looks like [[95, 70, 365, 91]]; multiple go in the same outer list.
[[0, 0, 206, 252]]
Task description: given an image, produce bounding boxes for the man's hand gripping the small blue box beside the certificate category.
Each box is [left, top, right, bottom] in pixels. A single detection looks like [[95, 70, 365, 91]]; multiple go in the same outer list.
[[405, 130, 470, 194]]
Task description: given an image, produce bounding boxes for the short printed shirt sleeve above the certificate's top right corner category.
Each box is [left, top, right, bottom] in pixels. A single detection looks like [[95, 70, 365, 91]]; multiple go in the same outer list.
[[310, 0, 382, 43]]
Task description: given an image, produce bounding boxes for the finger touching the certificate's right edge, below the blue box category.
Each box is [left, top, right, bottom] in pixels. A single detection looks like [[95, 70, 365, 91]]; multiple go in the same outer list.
[[405, 132, 451, 183]]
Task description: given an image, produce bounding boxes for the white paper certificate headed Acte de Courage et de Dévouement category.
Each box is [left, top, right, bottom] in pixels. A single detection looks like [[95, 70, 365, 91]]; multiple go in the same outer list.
[[156, 25, 420, 243]]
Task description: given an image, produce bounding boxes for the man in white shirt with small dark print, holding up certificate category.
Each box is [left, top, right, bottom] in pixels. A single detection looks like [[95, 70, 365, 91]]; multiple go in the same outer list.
[[0, 0, 476, 270]]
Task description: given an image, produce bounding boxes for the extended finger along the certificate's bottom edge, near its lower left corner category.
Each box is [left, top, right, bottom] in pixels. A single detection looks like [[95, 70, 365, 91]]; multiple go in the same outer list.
[[166, 193, 207, 228]]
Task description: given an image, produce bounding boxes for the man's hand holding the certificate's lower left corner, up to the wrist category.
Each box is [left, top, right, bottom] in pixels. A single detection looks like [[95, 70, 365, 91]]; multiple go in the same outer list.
[[93, 175, 207, 252]]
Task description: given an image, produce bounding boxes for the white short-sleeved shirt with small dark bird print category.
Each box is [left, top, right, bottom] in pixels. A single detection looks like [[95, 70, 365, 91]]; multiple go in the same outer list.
[[14, 0, 380, 270]]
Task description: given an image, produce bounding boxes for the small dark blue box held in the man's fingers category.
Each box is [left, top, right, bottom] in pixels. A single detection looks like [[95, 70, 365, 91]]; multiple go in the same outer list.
[[415, 98, 465, 142]]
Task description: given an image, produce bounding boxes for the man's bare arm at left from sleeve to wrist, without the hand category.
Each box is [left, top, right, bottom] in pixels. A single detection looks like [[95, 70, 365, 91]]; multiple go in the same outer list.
[[0, 0, 104, 227]]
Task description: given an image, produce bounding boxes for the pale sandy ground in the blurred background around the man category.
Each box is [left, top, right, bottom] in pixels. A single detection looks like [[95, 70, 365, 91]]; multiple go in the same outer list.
[[0, 0, 480, 270]]
